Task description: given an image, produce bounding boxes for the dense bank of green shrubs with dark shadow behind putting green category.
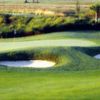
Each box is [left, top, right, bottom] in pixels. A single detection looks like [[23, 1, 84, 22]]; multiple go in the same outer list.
[[0, 15, 100, 37]]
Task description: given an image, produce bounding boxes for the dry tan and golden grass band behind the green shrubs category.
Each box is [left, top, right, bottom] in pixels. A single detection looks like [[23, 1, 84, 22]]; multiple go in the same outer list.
[[0, 4, 90, 16]]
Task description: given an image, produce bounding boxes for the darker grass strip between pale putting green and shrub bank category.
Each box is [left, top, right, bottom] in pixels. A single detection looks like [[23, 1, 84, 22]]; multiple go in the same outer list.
[[0, 31, 100, 41]]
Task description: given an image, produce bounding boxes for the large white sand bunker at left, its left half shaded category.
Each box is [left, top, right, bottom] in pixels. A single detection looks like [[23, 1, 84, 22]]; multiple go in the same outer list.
[[0, 60, 55, 68]]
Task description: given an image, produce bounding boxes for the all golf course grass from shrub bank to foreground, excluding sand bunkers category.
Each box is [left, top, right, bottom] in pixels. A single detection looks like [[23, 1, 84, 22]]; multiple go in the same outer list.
[[0, 31, 100, 100]]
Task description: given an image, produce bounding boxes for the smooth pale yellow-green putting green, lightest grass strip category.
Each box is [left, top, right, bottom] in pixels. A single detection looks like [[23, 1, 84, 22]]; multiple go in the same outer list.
[[0, 39, 97, 52]]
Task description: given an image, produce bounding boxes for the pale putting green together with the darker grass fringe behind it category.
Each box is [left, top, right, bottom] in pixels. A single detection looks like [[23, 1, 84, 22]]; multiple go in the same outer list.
[[0, 31, 100, 52]]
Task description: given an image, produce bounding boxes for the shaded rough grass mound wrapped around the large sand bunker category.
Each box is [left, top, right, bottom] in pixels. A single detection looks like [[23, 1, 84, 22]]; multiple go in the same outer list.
[[0, 47, 100, 71]]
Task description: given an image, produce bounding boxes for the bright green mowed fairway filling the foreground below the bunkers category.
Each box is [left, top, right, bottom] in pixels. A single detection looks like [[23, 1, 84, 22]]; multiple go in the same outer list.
[[0, 70, 100, 100]]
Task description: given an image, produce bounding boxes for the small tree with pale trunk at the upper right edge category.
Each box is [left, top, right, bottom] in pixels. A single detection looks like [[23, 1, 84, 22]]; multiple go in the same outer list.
[[90, 3, 100, 23]]
